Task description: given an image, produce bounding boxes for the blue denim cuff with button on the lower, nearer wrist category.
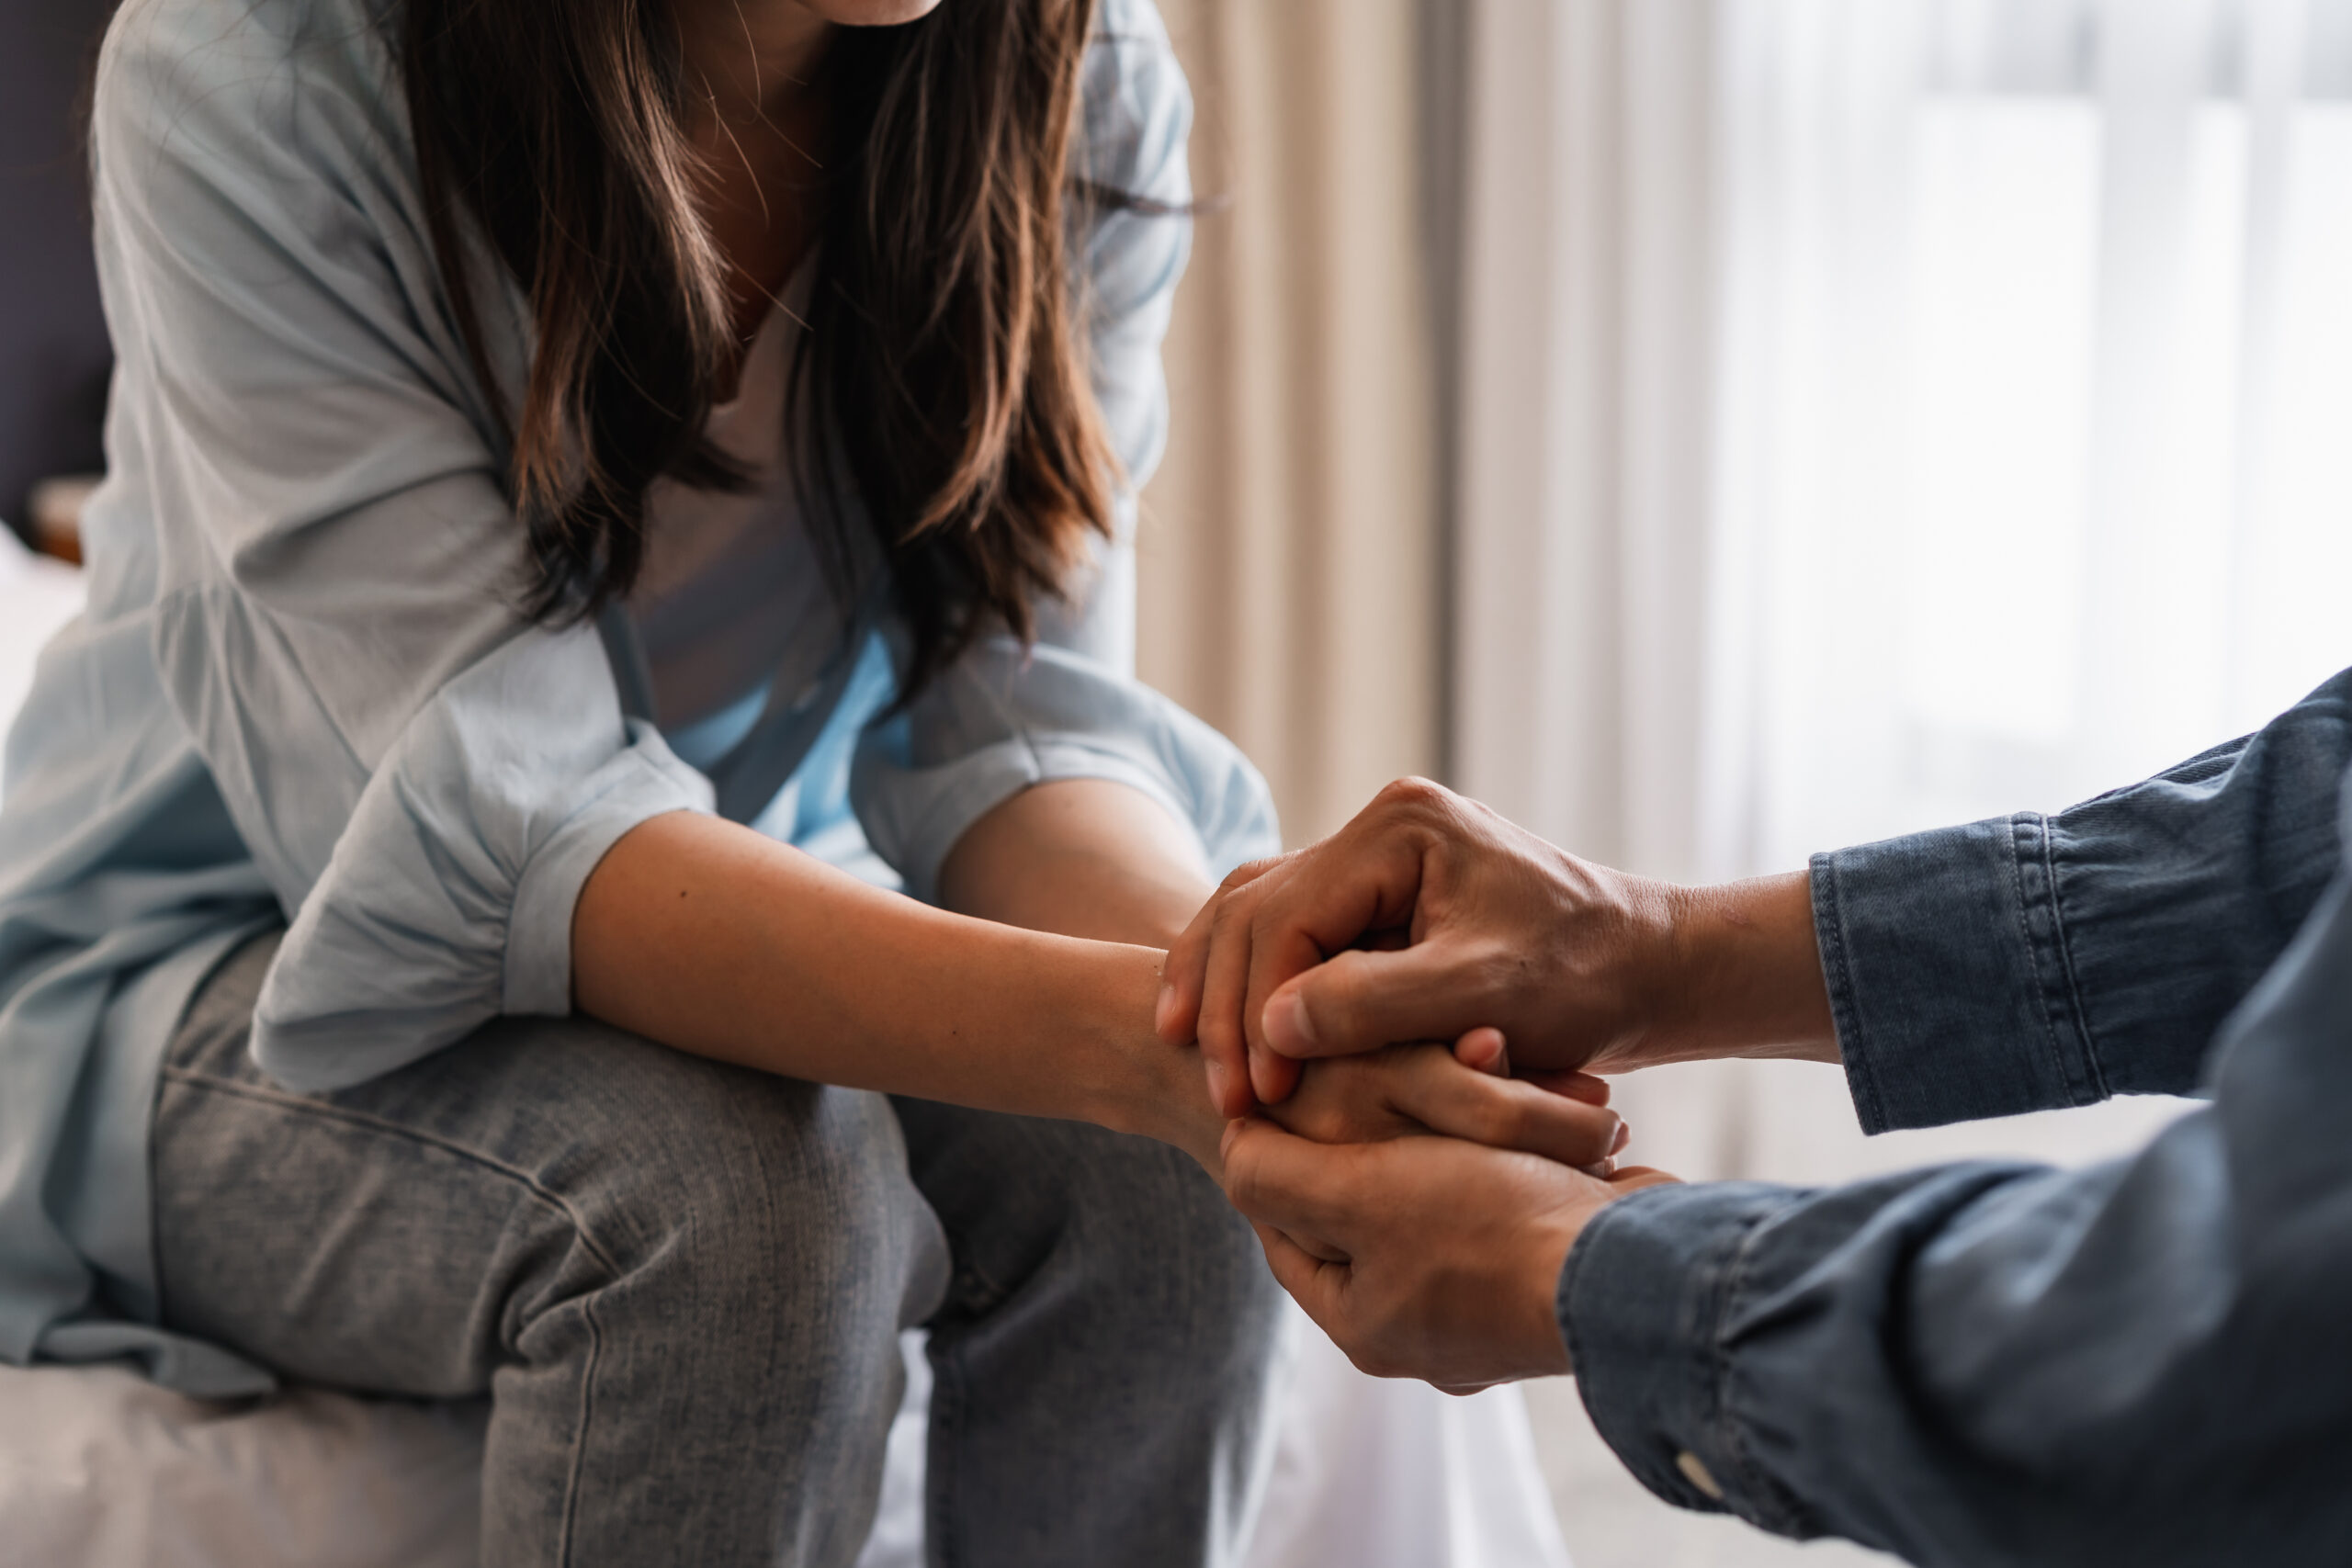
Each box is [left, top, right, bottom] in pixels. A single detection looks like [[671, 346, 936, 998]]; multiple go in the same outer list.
[[1557, 1182, 1806, 1535]]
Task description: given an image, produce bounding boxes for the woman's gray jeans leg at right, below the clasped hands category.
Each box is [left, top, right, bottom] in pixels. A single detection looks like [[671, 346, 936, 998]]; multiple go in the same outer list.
[[896, 1100, 1282, 1568]]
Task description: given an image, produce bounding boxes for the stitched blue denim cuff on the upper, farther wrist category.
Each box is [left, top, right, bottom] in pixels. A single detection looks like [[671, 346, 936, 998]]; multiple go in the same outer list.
[[1814, 811, 2108, 1134]]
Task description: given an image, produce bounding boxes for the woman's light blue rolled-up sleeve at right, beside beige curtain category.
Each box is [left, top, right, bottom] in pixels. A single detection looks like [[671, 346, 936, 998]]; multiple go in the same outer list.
[[852, 0, 1280, 898]]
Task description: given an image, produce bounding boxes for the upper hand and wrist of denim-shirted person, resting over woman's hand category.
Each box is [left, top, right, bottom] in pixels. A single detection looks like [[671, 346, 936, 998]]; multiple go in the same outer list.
[[1155, 781, 1837, 1117]]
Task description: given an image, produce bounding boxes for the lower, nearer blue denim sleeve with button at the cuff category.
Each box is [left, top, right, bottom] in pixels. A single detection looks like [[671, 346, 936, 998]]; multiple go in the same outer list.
[[1559, 808, 2352, 1568]]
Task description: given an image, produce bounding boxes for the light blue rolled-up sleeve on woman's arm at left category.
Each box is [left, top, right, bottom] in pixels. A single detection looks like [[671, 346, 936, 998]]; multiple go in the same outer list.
[[94, 0, 710, 1090]]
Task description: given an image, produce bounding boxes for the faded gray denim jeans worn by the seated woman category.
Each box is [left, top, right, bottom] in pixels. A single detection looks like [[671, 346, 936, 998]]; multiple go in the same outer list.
[[153, 938, 1277, 1568]]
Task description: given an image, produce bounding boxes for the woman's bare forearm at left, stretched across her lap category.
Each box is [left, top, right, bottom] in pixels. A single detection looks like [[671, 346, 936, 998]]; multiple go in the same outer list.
[[571, 813, 1223, 1161]]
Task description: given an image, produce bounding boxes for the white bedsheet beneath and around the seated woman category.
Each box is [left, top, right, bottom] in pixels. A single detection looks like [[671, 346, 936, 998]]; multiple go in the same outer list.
[[0, 529, 1569, 1568]]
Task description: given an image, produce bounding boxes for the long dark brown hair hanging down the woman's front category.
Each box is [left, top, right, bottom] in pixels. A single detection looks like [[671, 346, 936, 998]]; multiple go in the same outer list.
[[395, 0, 1117, 691]]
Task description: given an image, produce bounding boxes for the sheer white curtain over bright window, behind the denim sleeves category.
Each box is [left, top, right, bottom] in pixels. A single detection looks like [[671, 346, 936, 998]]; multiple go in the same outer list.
[[1456, 0, 2352, 1178]]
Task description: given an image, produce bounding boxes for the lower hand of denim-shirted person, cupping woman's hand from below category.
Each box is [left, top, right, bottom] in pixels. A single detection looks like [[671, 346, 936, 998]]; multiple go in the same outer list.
[[1223, 1123, 1675, 1394]]
